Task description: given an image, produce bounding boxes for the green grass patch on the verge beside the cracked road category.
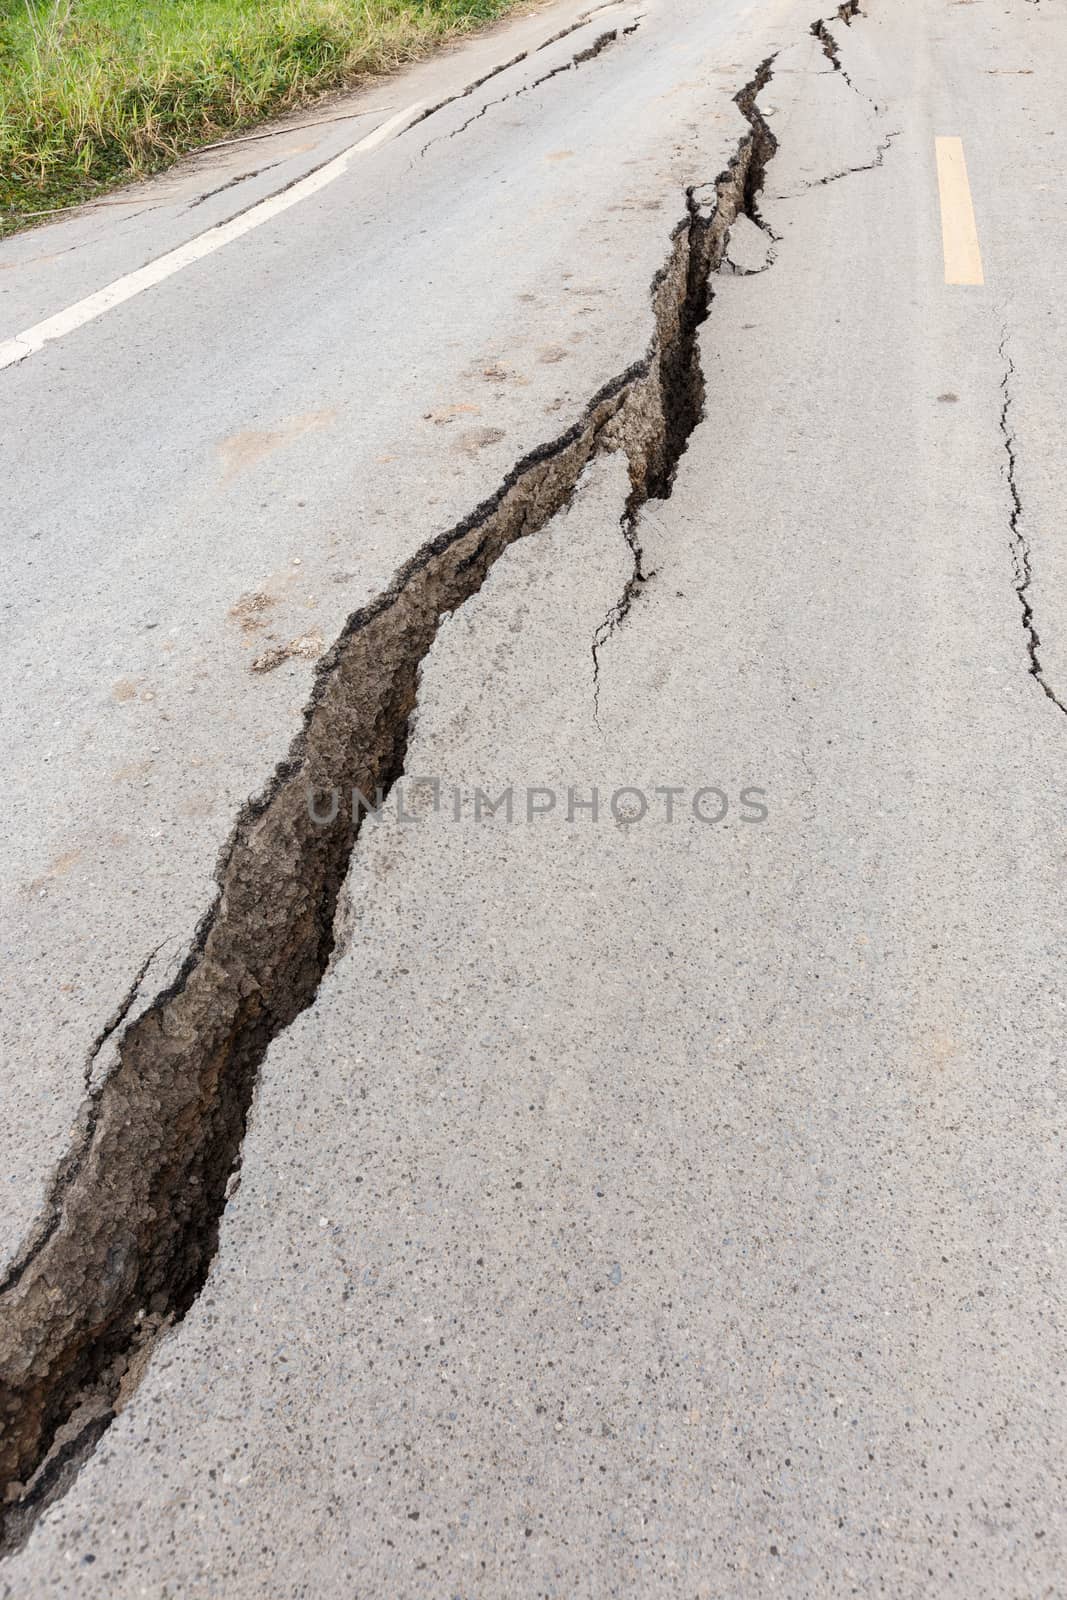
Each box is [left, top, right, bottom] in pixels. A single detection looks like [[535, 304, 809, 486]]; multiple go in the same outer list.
[[0, 0, 517, 235]]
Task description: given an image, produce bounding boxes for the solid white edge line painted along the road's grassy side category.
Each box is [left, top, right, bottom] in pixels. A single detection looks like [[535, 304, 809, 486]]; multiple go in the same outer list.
[[0, 101, 424, 368]]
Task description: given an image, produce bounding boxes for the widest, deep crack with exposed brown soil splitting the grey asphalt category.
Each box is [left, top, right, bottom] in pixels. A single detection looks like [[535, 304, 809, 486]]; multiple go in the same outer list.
[[0, 61, 793, 1550]]
